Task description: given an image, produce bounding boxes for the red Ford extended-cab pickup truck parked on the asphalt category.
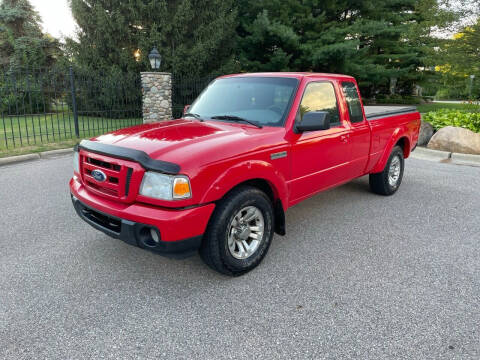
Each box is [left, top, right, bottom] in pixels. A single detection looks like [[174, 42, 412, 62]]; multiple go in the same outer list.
[[70, 73, 420, 276]]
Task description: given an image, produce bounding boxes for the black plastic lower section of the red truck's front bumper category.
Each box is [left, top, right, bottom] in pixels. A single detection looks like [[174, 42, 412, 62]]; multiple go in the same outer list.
[[71, 195, 203, 258]]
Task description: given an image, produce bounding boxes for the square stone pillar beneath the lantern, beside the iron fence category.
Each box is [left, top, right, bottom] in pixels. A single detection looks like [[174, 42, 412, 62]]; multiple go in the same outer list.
[[140, 72, 173, 124]]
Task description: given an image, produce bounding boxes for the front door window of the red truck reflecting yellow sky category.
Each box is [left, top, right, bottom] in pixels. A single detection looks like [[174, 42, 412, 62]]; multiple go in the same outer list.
[[298, 82, 340, 126]]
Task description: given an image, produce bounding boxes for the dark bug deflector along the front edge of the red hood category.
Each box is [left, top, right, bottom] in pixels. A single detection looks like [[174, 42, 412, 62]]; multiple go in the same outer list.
[[78, 140, 180, 175]]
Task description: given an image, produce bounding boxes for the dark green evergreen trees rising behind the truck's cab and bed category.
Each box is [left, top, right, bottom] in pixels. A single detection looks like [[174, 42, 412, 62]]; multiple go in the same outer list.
[[237, 0, 468, 96]]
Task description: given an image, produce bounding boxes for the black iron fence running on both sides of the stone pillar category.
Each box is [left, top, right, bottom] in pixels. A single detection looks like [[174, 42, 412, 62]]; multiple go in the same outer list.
[[0, 67, 214, 154]]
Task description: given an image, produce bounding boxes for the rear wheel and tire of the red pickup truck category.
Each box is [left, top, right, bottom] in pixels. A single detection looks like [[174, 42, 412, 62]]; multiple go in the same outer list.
[[369, 146, 405, 196]]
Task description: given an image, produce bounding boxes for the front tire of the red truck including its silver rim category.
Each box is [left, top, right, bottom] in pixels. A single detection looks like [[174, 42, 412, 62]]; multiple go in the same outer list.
[[200, 186, 274, 276]]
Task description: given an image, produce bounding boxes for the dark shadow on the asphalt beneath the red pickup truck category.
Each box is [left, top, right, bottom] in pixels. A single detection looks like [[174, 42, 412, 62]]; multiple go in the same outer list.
[[87, 177, 372, 284]]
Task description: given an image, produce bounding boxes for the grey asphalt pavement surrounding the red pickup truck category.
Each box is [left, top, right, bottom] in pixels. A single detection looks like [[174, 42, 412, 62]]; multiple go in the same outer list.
[[0, 156, 480, 360]]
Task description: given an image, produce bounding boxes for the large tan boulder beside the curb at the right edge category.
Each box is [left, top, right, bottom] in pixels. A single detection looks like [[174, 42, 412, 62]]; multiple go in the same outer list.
[[427, 126, 480, 155]]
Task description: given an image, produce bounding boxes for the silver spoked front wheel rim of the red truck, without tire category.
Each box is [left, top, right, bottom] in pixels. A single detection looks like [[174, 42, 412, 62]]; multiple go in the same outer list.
[[228, 206, 265, 260]]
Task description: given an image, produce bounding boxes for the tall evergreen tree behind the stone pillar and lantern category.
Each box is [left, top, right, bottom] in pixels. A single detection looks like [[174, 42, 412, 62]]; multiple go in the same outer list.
[[66, 0, 236, 114]]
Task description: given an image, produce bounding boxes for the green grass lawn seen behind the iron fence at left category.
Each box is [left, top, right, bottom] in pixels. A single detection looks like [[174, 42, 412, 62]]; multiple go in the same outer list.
[[0, 112, 142, 157]]
